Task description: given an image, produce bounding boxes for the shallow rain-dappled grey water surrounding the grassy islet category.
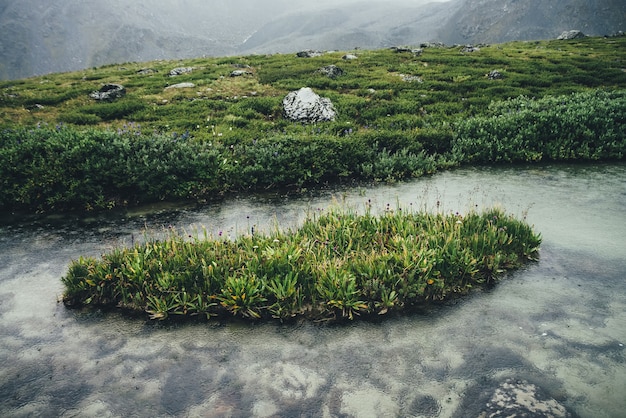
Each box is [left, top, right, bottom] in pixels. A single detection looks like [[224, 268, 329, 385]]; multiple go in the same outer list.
[[0, 164, 626, 418]]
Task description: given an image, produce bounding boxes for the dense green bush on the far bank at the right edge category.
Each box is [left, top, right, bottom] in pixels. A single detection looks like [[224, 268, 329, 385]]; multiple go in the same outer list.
[[452, 90, 626, 163]]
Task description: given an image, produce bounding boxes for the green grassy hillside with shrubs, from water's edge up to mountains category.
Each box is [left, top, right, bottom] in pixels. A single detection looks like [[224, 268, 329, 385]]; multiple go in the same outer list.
[[0, 37, 626, 211]]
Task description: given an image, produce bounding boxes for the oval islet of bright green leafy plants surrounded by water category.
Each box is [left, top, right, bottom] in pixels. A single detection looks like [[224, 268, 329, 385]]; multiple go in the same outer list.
[[62, 209, 541, 320]]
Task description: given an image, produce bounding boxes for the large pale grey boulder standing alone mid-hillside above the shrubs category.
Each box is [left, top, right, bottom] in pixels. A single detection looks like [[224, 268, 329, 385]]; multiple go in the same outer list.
[[283, 87, 337, 123]]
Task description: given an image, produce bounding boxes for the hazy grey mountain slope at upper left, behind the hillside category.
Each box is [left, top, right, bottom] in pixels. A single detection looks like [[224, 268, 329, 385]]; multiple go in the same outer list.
[[0, 0, 287, 79]]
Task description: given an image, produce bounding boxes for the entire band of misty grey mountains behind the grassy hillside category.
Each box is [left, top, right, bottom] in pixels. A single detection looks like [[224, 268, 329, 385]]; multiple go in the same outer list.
[[0, 0, 626, 79]]
